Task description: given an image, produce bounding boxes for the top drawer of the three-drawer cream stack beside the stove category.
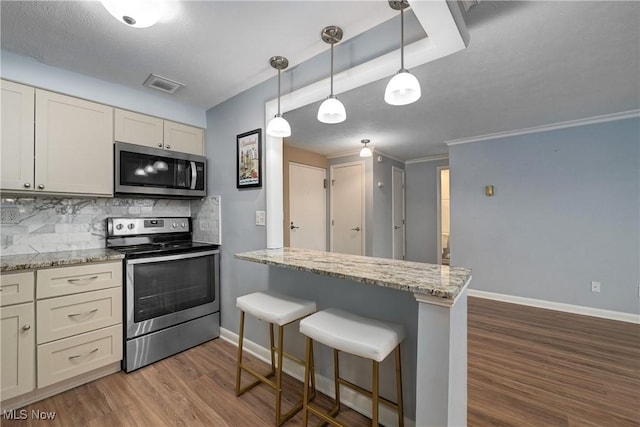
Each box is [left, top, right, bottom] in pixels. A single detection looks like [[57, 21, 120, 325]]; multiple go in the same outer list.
[[36, 261, 122, 299]]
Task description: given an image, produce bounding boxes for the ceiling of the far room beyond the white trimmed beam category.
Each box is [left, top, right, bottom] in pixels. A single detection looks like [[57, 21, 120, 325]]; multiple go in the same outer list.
[[284, 1, 640, 160]]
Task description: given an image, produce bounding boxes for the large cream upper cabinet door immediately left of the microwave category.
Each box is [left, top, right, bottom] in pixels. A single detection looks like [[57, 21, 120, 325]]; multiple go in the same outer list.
[[35, 89, 113, 196]]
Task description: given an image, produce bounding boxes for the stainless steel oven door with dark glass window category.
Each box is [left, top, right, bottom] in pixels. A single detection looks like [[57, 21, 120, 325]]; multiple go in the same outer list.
[[125, 250, 220, 339]]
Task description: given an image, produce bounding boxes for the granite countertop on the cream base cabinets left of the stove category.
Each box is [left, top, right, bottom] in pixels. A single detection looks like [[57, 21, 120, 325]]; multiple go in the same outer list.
[[0, 248, 124, 273]]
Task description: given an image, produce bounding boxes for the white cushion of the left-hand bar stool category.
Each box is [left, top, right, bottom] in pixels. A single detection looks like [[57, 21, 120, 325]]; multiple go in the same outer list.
[[236, 291, 316, 326]]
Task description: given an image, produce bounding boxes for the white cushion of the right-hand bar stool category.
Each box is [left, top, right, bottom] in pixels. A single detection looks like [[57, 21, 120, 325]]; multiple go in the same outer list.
[[300, 308, 405, 362]]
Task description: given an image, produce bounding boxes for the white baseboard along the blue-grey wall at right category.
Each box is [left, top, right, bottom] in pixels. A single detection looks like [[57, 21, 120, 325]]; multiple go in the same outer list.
[[468, 289, 640, 324]]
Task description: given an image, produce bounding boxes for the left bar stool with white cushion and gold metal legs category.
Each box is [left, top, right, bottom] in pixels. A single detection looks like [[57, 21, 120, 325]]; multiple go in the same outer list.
[[236, 291, 316, 427]]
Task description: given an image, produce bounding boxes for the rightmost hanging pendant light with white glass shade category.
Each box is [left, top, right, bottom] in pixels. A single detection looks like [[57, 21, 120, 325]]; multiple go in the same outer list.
[[384, 0, 421, 105]]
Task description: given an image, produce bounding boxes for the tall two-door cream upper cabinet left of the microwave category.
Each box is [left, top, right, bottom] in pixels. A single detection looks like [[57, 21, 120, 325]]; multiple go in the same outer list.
[[0, 80, 113, 196]]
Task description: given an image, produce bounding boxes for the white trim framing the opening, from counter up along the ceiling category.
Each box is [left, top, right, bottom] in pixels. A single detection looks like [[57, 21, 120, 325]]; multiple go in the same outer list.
[[265, 0, 466, 249]]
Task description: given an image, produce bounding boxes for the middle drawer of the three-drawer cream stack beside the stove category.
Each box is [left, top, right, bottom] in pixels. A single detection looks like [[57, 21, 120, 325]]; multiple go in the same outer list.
[[36, 288, 122, 344]]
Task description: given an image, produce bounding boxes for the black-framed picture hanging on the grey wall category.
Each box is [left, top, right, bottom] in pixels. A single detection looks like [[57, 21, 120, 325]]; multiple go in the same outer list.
[[236, 129, 262, 188]]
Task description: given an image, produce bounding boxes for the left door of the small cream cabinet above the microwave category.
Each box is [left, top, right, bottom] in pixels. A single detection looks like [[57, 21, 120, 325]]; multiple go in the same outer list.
[[114, 108, 164, 148]]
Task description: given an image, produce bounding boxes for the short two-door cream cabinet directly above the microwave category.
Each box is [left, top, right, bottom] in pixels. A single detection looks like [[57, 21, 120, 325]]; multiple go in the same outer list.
[[114, 109, 204, 156]]
